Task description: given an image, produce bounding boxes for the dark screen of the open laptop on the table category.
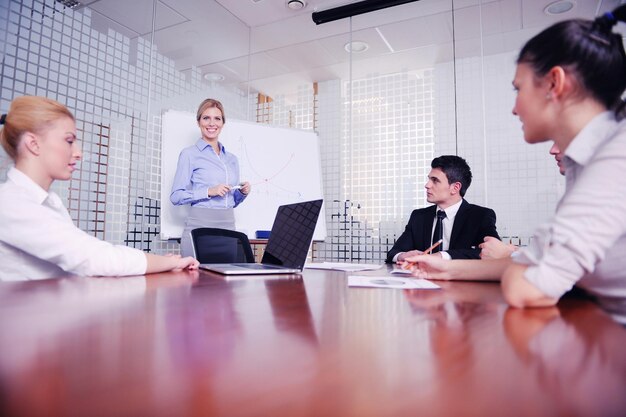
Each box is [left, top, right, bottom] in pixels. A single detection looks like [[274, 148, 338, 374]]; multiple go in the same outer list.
[[261, 200, 322, 270]]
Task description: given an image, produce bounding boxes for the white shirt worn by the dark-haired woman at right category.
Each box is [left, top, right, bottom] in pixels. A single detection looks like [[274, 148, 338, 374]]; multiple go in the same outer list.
[[513, 112, 626, 320]]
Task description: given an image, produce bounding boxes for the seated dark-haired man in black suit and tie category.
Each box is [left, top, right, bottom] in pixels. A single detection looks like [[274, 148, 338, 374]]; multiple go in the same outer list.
[[386, 155, 500, 263]]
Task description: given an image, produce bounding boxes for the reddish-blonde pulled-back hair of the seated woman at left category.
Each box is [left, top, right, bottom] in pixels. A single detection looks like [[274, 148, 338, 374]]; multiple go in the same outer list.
[[0, 96, 75, 161]]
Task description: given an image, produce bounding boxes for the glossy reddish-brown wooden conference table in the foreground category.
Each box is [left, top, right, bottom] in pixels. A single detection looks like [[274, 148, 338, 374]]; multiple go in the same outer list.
[[0, 269, 626, 417]]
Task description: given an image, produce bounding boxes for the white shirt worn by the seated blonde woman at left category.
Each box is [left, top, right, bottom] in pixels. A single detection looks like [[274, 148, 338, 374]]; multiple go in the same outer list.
[[0, 168, 147, 281]]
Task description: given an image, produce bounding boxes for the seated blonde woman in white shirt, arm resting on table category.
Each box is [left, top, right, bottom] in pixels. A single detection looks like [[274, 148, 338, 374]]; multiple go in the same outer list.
[[0, 96, 198, 281]]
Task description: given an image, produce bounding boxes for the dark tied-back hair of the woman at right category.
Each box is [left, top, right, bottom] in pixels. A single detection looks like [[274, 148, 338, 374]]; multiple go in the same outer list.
[[517, 5, 626, 113]]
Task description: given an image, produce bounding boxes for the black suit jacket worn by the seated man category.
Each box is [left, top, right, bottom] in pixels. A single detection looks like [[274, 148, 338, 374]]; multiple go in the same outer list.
[[386, 199, 500, 263]]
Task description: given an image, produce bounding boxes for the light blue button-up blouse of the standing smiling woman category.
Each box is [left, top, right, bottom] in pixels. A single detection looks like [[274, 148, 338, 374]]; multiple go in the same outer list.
[[170, 139, 246, 209]]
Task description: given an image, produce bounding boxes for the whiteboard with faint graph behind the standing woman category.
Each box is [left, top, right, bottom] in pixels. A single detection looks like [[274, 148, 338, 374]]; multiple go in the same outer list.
[[161, 110, 326, 240]]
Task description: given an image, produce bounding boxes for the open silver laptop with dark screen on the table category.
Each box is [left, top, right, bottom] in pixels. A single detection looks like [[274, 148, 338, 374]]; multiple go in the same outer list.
[[200, 199, 323, 275]]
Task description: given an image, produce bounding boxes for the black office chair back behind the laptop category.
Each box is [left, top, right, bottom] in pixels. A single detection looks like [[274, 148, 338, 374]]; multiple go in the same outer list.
[[191, 227, 254, 264]]
